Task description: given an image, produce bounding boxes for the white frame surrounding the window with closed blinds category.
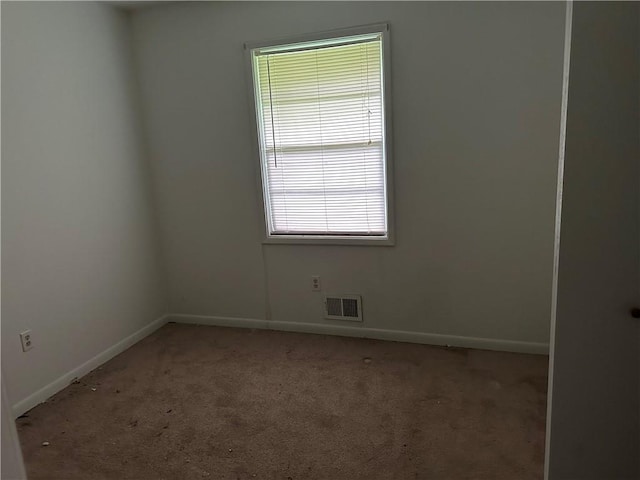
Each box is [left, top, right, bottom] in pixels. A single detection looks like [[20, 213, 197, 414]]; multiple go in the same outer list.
[[244, 23, 395, 246]]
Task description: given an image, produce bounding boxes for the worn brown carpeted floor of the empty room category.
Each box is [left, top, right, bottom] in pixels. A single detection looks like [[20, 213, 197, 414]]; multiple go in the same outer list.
[[17, 323, 548, 480]]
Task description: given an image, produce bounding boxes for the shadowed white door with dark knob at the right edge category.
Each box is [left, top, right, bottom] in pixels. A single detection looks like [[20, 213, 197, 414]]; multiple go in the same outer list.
[[547, 2, 640, 480]]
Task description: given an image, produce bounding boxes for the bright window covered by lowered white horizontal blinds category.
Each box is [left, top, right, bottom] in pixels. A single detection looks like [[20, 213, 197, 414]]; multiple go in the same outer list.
[[248, 25, 391, 244]]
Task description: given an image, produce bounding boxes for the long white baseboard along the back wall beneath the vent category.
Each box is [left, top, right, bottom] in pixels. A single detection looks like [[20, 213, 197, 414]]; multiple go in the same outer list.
[[168, 314, 549, 355]]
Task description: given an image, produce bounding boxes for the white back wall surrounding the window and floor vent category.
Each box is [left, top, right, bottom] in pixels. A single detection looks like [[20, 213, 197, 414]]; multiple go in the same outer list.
[[133, 2, 564, 349]]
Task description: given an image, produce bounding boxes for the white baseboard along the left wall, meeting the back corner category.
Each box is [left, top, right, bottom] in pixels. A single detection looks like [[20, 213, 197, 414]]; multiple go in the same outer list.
[[12, 315, 168, 418]]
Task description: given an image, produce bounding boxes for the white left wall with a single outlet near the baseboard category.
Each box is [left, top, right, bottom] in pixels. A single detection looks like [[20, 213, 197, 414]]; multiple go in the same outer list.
[[2, 2, 166, 408]]
